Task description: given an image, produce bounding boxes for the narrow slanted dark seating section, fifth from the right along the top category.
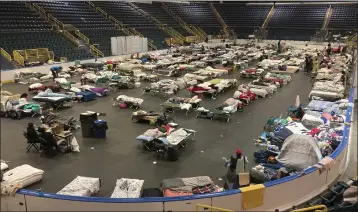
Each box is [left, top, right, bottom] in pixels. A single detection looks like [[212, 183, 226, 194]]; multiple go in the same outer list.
[[134, 2, 190, 36]]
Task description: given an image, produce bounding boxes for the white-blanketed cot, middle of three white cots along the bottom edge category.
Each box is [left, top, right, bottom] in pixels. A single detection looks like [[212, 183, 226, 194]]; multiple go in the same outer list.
[[57, 176, 100, 197]]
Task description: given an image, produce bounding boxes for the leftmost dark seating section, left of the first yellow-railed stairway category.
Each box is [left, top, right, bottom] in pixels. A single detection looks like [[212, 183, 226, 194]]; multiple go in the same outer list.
[[0, 1, 92, 63]]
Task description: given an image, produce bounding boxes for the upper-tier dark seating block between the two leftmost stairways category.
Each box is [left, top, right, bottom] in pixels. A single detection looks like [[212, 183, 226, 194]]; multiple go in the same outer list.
[[36, 1, 114, 30]]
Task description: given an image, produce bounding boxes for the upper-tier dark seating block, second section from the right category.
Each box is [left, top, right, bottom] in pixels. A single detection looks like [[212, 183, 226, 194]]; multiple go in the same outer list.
[[268, 4, 329, 29]]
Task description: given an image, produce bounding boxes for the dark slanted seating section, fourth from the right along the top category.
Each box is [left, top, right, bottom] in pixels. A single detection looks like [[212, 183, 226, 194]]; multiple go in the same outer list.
[[165, 3, 221, 34]]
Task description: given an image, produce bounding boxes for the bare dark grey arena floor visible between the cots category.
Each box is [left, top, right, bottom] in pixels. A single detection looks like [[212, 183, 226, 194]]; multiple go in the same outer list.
[[1, 66, 311, 197]]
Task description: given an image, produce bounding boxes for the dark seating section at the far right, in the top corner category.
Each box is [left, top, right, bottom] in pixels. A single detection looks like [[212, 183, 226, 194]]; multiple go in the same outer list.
[[328, 4, 358, 29]]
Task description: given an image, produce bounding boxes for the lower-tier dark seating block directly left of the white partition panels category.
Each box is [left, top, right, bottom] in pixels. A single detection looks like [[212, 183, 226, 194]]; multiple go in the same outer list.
[[81, 29, 125, 56]]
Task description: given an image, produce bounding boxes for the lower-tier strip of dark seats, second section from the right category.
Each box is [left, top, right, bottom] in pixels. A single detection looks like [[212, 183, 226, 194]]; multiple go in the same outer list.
[[266, 28, 316, 41]]
